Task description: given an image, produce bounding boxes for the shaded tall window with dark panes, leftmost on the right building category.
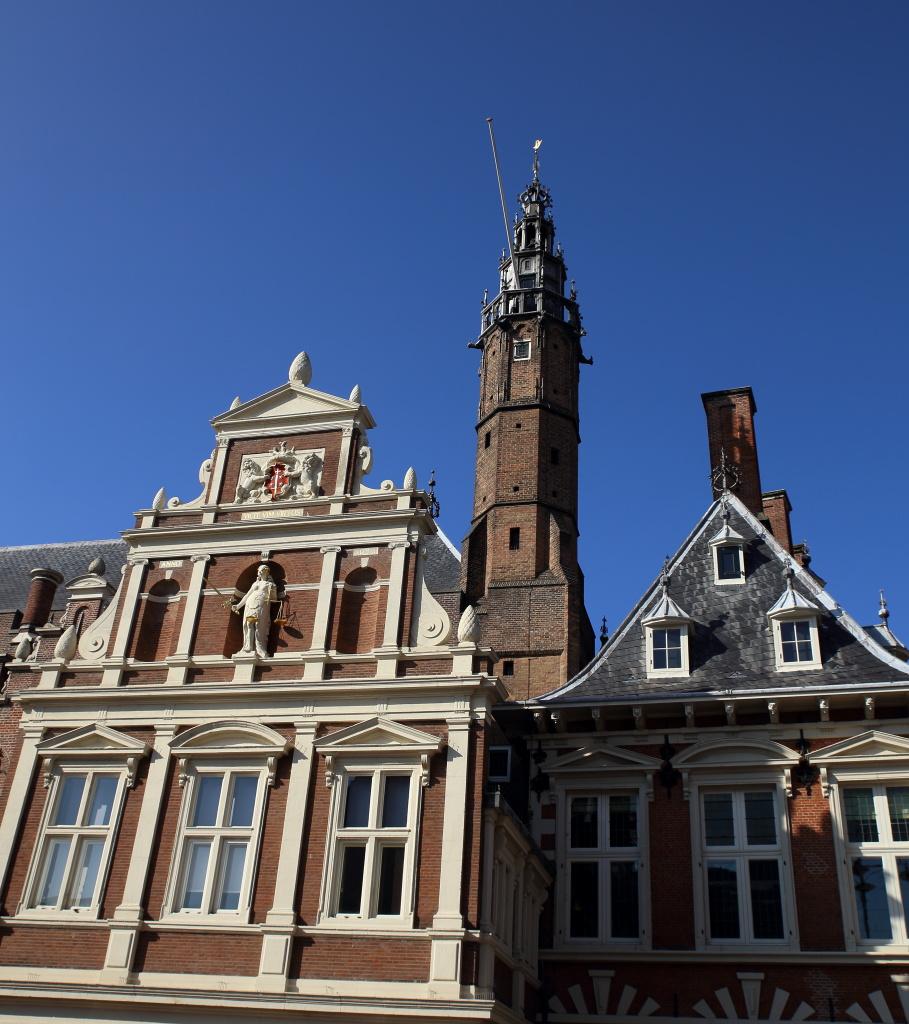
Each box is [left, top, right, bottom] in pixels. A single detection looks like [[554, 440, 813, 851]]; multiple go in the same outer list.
[[566, 793, 641, 943]]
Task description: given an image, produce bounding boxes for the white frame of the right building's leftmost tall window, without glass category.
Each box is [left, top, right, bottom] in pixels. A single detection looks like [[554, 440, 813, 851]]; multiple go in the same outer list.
[[559, 781, 650, 949]]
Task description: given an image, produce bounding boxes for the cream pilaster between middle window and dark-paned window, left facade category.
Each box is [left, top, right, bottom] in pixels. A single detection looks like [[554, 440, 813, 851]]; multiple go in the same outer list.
[[256, 719, 317, 992]]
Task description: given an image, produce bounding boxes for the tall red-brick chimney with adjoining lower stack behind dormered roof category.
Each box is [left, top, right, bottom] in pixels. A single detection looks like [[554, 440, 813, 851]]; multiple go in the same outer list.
[[701, 387, 792, 553]]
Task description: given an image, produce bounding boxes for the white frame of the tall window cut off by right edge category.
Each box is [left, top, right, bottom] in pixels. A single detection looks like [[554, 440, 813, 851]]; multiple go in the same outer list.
[[825, 765, 909, 952]]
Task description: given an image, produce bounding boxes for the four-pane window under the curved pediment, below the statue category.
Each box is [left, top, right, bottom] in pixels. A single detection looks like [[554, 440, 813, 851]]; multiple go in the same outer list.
[[172, 769, 263, 914]]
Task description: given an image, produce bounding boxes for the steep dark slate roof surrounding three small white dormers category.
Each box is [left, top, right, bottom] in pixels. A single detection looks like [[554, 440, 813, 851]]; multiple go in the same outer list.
[[539, 496, 909, 703]]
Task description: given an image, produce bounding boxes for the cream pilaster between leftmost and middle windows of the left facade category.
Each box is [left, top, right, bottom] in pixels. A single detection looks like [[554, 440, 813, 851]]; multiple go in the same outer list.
[[100, 722, 176, 985]]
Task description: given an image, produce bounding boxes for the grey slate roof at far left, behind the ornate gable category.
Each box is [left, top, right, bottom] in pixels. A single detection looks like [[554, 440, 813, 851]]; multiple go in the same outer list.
[[0, 540, 126, 611]]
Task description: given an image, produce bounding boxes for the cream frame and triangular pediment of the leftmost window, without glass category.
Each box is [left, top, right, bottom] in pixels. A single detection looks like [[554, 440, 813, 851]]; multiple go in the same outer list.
[[16, 725, 149, 921]]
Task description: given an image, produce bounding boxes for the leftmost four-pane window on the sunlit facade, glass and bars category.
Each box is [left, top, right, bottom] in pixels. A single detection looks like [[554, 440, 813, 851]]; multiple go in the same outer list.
[[28, 770, 124, 910]]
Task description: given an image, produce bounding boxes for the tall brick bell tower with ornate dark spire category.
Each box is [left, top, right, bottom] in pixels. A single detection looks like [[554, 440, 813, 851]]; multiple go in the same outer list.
[[462, 153, 594, 700]]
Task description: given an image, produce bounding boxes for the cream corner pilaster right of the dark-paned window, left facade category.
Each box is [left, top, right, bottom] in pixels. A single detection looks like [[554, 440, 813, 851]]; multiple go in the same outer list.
[[430, 715, 470, 990]]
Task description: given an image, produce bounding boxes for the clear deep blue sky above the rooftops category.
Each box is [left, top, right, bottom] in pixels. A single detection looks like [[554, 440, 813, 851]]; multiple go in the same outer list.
[[0, 0, 909, 640]]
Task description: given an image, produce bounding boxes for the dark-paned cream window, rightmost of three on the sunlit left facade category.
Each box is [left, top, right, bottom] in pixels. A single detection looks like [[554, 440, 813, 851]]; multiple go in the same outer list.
[[330, 769, 418, 920]]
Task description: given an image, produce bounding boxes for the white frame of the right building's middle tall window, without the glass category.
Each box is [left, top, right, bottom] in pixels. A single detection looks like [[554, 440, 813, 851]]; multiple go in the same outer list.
[[686, 778, 798, 951]]
